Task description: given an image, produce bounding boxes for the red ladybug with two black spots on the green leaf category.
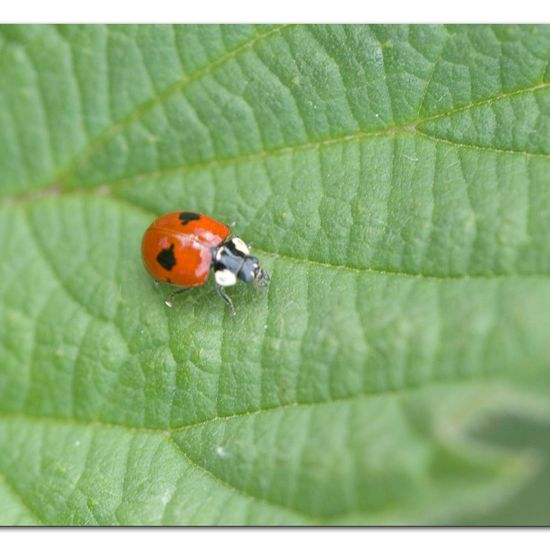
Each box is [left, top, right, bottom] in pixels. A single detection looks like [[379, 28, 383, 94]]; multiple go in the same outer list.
[[141, 212, 269, 316]]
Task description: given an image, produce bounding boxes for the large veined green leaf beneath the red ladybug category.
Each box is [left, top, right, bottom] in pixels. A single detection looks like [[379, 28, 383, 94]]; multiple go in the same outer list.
[[0, 25, 550, 525]]
